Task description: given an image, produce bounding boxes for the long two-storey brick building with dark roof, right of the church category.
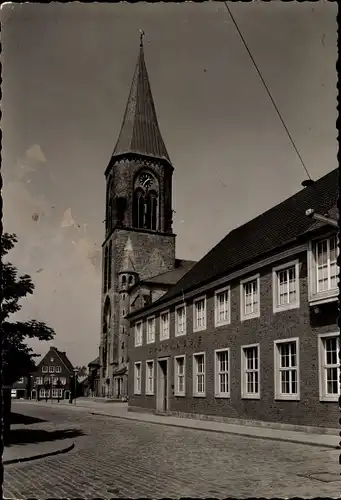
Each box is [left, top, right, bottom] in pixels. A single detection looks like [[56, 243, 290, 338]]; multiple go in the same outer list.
[[127, 170, 340, 427]]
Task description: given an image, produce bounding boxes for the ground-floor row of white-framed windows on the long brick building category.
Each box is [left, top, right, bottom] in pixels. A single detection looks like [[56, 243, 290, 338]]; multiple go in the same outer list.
[[134, 333, 340, 401]]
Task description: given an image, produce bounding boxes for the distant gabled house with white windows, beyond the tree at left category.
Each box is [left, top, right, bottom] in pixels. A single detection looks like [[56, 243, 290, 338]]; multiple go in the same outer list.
[[31, 347, 74, 399]]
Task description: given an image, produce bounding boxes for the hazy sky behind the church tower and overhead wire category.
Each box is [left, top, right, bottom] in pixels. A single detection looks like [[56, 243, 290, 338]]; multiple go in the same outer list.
[[1, 1, 337, 365]]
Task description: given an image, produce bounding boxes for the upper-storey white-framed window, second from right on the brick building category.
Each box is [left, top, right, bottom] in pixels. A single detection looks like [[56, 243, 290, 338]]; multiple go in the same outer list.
[[272, 260, 300, 312]]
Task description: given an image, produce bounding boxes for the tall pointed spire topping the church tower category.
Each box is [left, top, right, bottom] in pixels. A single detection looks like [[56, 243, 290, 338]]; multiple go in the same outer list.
[[113, 31, 170, 163]]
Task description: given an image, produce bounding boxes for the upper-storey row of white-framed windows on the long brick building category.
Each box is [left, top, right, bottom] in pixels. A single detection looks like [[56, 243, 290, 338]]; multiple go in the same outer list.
[[135, 236, 338, 347]]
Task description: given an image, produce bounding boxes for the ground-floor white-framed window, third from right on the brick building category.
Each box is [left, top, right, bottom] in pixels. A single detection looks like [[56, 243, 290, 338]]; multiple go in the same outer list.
[[241, 344, 260, 399]]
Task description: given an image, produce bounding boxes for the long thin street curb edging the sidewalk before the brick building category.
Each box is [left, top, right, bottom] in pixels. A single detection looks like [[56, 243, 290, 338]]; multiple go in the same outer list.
[[89, 412, 340, 450]]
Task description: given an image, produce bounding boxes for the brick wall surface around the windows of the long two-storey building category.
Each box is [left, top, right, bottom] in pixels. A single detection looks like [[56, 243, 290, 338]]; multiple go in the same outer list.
[[129, 249, 339, 427]]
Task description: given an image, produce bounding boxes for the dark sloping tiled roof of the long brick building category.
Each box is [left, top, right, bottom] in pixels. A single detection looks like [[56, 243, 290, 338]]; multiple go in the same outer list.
[[144, 169, 339, 306]]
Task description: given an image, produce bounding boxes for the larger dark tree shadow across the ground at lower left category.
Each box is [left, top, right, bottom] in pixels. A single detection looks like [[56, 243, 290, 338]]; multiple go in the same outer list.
[[5, 429, 85, 447]]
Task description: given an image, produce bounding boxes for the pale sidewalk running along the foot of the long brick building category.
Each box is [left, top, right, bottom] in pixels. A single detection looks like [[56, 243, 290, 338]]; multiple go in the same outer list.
[[20, 398, 340, 449]]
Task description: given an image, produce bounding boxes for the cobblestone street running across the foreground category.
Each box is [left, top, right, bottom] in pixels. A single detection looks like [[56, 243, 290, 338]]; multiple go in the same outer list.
[[4, 403, 341, 499]]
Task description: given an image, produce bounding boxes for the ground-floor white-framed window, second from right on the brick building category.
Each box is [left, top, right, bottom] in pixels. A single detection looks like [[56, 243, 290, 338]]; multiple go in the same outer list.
[[274, 339, 300, 400]]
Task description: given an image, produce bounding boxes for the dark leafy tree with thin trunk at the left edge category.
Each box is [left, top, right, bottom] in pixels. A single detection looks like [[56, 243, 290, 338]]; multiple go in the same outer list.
[[0, 233, 55, 437]]
